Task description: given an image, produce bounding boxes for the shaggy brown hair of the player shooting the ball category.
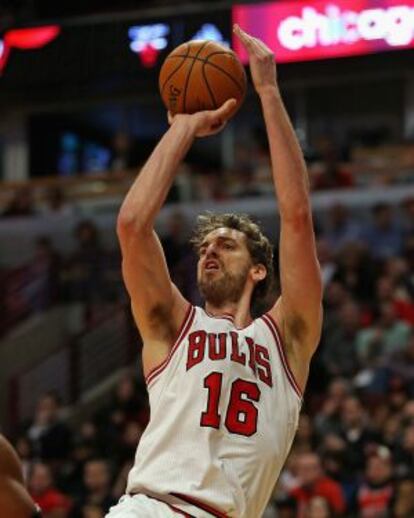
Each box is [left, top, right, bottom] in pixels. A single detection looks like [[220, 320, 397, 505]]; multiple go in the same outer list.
[[191, 213, 274, 307]]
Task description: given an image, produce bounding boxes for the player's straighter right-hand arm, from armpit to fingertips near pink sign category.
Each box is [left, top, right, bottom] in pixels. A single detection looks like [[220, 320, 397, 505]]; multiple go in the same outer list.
[[235, 26, 322, 386]]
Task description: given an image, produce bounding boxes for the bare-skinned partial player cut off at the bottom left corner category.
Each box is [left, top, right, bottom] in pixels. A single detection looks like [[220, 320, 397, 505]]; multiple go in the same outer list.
[[0, 434, 42, 518]]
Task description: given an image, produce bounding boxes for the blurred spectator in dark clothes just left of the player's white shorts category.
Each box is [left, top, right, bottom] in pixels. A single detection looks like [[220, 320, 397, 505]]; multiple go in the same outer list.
[[71, 458, 116, 518]]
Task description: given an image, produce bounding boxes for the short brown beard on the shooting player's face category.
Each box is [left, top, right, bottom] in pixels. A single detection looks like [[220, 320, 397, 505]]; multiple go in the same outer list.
[[198, 265, 250, 308]]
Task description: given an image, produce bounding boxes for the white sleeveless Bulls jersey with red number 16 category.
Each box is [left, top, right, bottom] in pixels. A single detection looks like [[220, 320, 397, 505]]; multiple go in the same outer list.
[[127, 306, 302, 518]]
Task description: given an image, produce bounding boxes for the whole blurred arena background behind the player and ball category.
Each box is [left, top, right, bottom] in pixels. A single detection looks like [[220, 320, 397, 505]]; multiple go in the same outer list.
[[0, 0, 414, 518]]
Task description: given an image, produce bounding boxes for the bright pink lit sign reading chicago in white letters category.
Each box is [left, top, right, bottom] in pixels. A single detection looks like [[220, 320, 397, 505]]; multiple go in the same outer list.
[[232, 0, 414, 63]]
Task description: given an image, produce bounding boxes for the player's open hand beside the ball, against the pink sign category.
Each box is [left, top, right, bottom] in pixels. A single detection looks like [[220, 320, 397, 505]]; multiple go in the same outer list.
[[233, 24, 277, 94]]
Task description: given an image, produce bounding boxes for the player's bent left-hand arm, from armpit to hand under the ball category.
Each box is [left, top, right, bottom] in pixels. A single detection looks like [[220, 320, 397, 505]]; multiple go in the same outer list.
[[117, 100, 234, 364]]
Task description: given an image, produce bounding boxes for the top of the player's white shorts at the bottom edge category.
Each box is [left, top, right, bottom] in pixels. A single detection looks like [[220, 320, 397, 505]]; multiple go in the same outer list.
[[105, 494, 186, 518]]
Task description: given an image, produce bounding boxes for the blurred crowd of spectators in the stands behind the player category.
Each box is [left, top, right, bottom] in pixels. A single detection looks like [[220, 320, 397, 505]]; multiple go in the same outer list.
[[2, 182, 414, 518]]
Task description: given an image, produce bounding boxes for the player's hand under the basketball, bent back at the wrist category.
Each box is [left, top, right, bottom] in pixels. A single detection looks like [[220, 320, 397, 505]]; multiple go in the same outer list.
[[168, 99, 236, 137]]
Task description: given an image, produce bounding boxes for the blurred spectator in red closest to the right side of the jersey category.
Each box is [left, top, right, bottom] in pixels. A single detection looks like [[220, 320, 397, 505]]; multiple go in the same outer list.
[[291, 453, 345, 518]]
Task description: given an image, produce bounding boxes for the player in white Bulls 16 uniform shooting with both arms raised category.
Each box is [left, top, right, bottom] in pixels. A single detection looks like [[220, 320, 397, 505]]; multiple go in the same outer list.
[[107, 27, 322, 518]]
